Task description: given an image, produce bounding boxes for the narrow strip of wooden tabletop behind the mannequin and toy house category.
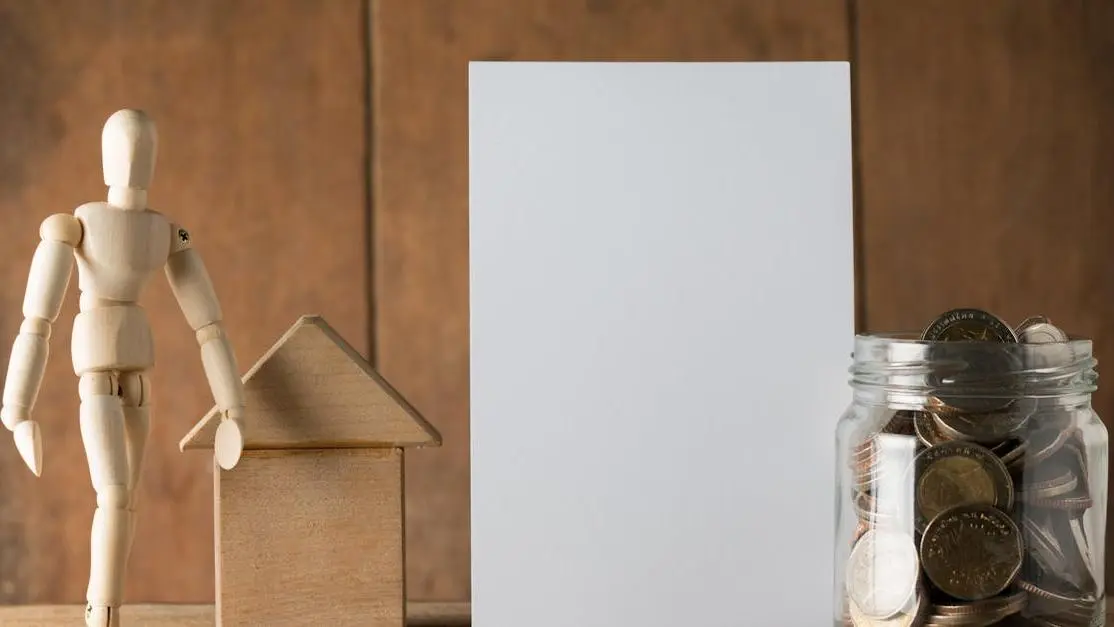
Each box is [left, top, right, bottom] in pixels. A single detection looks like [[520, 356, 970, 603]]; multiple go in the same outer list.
[[0, 602, 471, 627]]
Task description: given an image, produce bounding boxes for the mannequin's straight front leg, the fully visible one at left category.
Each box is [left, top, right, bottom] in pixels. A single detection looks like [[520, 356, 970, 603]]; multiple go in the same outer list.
[[78, 372, 128, 627]]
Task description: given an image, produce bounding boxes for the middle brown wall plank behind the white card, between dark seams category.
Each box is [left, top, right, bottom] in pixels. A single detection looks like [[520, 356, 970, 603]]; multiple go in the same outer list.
[[371, 0, 849, 599]]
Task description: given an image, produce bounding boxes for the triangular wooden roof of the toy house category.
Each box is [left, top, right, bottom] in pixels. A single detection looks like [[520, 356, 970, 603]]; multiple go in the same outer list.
[[179, 316, 441, 450]]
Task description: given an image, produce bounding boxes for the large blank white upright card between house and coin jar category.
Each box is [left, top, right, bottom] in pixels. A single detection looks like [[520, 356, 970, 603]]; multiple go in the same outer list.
[[469, 62, 853, 627]]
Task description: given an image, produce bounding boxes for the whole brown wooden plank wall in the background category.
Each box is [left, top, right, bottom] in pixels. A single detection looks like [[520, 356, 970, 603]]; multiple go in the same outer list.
[[0, 0, 1114, 602]]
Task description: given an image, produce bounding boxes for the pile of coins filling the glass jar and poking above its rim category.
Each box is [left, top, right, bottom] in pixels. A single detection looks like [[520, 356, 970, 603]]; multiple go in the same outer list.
[[843, 308, 1105, 627]]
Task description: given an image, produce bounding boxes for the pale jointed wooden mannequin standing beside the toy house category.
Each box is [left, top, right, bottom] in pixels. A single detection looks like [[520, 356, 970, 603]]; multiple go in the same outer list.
[[0, 109, 244, 627]]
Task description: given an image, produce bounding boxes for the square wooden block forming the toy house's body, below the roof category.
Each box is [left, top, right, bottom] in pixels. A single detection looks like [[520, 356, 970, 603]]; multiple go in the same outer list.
[[216, 449, 405, 627]]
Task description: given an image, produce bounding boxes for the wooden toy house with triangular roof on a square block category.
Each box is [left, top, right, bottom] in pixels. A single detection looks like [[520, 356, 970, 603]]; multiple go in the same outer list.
[[180, 316, 441, 627]]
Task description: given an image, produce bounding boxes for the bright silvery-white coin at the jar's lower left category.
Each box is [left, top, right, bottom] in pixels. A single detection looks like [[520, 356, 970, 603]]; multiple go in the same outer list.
[[847, 529, 920, 618]]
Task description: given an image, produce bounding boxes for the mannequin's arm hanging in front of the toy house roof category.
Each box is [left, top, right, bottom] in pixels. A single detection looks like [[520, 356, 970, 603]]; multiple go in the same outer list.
[[166, 225, 244, 470]]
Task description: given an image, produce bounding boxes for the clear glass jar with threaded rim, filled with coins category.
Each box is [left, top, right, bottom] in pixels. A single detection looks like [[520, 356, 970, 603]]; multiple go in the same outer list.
[[834, 332, 1107, 627]]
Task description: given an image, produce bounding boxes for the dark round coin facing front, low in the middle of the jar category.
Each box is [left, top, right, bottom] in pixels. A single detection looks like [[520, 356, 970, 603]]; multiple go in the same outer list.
[[920, 504, 1024, 600]]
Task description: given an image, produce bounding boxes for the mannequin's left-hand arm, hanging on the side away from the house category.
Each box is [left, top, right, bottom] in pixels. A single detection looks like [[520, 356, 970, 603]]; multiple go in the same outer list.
[[0, 214, 82, 477]]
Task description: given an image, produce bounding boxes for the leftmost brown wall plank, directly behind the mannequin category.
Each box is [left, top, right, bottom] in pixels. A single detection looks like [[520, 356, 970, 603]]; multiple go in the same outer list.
[[0, 0, 368, 602]]
